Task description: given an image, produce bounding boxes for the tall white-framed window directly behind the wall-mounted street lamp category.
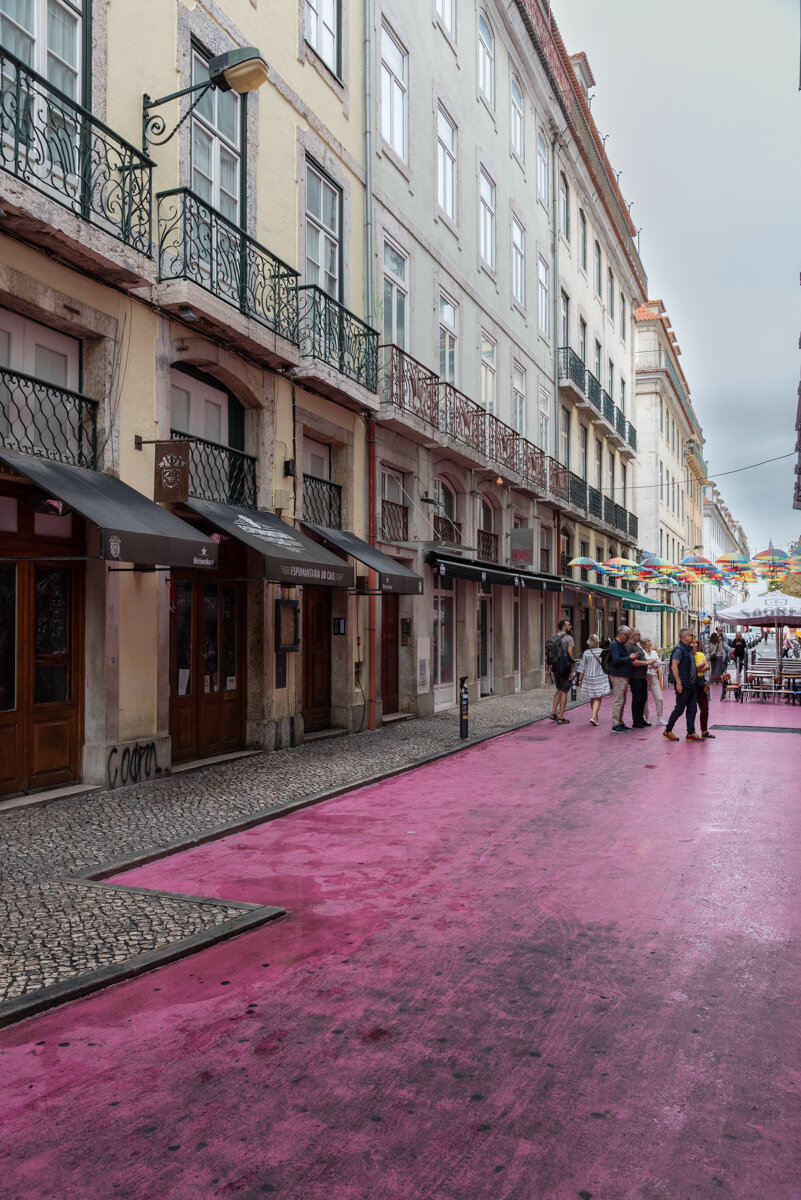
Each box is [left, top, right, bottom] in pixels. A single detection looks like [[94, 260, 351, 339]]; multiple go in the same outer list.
[[192, 50, 242, 224]]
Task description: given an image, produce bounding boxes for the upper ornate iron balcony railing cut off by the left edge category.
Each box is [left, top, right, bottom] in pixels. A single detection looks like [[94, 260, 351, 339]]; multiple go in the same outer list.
[[0, 49, 153, 257]]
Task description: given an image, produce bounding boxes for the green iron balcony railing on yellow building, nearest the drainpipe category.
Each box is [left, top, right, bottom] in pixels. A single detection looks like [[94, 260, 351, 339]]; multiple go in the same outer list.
[[297, 283, 378, 391]]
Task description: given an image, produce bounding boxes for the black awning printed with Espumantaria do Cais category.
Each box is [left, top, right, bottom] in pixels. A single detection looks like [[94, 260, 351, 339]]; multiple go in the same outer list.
[[186, 497, 354, 588]]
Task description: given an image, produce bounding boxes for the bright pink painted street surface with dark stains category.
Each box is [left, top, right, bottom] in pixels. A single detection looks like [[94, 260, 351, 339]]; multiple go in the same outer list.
[[0, 702, 801, 1200]]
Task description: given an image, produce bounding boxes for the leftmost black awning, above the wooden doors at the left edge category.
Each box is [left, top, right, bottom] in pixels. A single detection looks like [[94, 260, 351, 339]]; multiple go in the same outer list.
[[0, 448, 217, 566]]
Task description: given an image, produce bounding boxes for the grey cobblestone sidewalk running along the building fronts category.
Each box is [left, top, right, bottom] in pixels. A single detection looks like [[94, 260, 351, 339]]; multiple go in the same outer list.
[[0, 686, 573, 1002]]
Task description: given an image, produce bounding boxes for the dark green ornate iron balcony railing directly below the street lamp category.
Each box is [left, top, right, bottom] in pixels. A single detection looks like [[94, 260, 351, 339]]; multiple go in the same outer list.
[[157, 187, 299, 346]]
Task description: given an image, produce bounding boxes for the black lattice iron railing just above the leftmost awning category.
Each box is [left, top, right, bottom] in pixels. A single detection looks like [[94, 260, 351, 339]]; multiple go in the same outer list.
[[0, 367, 97, 470]]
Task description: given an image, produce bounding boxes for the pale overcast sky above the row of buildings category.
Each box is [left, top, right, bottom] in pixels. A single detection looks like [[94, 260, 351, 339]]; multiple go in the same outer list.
[[552, 0, 801, 553]]
